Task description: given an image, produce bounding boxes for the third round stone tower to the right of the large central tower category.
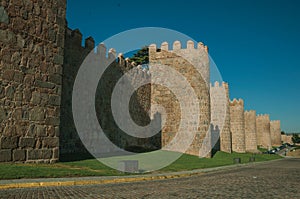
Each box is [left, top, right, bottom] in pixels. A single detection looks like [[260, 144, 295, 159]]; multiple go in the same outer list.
[[244, 110, 258, 152]]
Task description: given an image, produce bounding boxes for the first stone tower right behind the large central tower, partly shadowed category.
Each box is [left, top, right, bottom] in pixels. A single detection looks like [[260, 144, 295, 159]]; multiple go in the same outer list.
[[210, 82, 232, 153]]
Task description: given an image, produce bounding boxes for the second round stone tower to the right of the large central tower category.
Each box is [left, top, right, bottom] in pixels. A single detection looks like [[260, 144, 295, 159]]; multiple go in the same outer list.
[[230, 99, 246, 153]]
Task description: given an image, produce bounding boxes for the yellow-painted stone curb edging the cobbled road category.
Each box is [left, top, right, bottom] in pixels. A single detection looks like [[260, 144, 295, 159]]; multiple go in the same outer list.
[[0, 159, 282, 190]]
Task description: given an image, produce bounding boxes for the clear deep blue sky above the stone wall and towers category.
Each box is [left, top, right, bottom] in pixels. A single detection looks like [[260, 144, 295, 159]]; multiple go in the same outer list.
[[67, 0, 300, 132]]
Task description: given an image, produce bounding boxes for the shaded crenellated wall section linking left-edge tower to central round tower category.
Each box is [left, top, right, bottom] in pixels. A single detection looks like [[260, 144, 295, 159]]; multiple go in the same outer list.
[[60, 29, 161, 155]]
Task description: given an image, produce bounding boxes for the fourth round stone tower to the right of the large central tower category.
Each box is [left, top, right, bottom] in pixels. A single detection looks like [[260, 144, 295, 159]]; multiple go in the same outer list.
[[256, 114, 272, 149]]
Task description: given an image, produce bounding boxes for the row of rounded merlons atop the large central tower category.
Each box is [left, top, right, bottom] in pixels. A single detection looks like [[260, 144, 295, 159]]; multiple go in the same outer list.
[[149, 40, 208, 53]]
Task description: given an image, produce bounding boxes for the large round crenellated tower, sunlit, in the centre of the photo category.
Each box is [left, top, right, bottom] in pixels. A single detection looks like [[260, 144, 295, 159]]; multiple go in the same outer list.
[[149, 41, 211, 156]]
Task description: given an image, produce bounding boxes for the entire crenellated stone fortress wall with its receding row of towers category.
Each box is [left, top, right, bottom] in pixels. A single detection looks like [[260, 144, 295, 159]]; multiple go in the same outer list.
[[0, 0, 284, 163]]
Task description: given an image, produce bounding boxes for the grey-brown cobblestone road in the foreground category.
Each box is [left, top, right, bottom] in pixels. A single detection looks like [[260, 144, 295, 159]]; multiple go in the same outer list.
[[0, 159, 300, 199]]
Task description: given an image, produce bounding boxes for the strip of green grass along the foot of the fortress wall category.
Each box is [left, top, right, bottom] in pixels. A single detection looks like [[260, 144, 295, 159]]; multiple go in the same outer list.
[[0, 152, 280, 179]]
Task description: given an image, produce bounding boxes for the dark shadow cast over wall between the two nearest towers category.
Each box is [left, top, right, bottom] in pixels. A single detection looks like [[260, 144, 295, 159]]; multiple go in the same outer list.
[[60, 29, 161, 161]]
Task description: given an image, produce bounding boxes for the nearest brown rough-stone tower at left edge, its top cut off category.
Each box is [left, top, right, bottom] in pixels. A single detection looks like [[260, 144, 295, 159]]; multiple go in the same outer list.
[[0, 0, 66, 163]]
